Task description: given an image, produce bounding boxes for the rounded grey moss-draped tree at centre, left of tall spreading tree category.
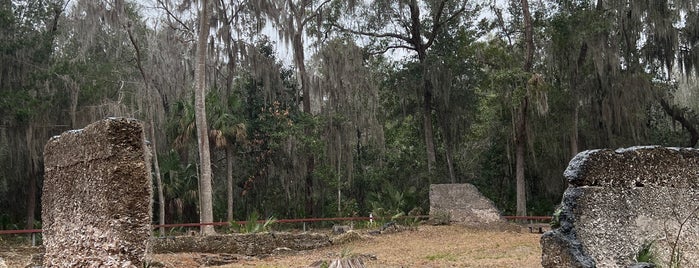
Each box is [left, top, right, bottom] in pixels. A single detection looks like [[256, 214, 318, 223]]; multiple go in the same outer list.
[[312, 38, 384, 216]]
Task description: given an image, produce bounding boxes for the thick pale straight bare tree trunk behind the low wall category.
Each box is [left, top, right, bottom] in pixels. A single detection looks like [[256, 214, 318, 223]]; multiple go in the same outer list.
[[194, 0, 216, 235]]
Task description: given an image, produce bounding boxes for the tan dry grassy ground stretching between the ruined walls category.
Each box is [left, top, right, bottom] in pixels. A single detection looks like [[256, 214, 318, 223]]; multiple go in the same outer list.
[[152, 225, 541, 267]]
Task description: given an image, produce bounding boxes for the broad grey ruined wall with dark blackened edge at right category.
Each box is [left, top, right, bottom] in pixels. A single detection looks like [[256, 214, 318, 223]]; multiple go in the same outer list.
[[541, 146, 699, 267]]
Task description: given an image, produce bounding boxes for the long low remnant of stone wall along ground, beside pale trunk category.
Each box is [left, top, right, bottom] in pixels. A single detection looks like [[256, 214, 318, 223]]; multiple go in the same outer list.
[[150, 232, 330, 256]]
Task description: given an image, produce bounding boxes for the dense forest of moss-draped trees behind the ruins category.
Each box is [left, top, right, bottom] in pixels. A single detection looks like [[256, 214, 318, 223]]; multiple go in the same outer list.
[[0, 0, 699, 233]]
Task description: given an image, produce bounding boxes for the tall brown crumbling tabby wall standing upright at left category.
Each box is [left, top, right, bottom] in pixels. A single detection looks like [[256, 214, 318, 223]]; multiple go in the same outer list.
[[41, 118, 152, 267]]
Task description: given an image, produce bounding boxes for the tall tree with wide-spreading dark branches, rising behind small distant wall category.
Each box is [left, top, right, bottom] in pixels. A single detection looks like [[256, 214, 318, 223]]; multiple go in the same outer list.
[[333, 0, 469, 175]]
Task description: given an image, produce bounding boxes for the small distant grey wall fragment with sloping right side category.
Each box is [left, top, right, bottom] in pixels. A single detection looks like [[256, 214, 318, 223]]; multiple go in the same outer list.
[[430, 183, 502, 224]]
